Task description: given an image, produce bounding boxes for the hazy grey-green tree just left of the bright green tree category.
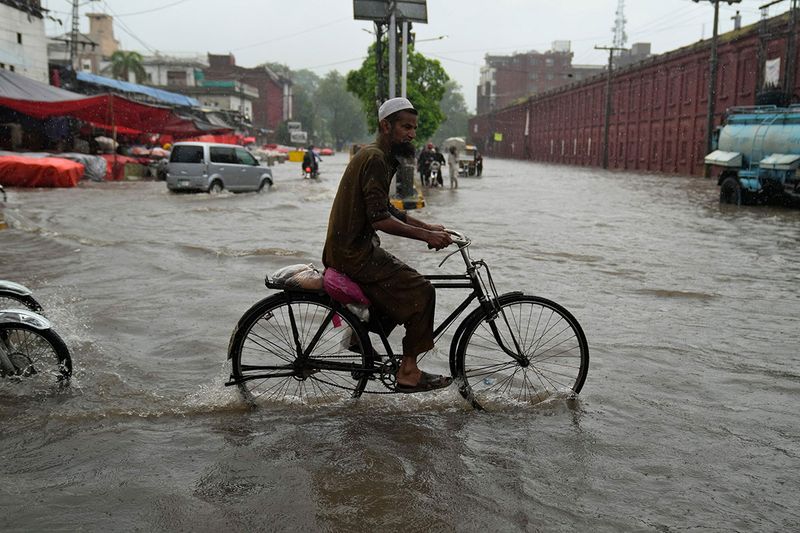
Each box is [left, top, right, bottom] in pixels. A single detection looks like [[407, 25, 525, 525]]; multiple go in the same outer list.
[[314, 70, 366, 150]]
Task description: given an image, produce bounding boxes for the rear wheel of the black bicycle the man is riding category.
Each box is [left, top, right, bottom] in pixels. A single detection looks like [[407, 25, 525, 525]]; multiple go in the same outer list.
[[228, 293, 372, 403]]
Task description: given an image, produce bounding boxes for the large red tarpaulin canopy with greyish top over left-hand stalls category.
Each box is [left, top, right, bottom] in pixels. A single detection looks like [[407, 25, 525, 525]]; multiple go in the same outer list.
[[0, 70, 230, 137]]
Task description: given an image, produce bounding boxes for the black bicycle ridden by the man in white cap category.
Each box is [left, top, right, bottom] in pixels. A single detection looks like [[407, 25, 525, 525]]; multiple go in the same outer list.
[[225, 230, 589, 409]]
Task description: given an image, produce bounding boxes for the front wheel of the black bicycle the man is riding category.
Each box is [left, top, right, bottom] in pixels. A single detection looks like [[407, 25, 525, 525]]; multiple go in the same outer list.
[[451, 294, 589, 408]]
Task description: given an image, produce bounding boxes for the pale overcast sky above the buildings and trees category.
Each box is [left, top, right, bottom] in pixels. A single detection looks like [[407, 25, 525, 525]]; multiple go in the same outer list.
[[42, 0, 790, 111]]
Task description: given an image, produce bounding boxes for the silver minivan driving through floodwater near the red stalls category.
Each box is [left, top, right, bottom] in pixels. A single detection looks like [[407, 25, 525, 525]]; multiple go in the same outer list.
[[167, 142, 272, 192]]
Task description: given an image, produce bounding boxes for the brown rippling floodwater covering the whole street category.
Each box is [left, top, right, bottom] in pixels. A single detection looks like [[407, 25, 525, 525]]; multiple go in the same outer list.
[[0, 155, 800, 532]]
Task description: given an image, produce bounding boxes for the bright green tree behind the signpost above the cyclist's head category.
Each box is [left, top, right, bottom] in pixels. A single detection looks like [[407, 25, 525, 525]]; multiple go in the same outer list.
[[347, 44, 450, 143]]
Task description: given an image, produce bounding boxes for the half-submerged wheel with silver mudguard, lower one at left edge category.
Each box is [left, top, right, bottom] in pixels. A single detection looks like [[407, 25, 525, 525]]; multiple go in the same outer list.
[[0, 323, 72, 382]]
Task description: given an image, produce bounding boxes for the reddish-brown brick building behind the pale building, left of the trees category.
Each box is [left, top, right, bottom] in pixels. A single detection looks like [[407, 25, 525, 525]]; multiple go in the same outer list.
[[205, 54, 292, 131]]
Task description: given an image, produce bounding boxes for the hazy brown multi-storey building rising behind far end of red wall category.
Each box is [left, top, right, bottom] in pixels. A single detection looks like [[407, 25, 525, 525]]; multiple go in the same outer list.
[[477, 41, 604, 114]]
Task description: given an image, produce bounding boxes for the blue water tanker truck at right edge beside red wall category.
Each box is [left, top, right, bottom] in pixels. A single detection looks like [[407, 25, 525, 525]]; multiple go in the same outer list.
[[705, 105, 800, 205]]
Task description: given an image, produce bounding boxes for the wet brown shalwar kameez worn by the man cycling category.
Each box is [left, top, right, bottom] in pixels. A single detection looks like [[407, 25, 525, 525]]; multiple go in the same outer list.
[[322, 144, 436, 356]]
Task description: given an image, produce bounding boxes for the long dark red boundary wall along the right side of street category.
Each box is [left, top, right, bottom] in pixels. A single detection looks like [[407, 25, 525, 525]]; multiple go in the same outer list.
[[468, 14, 800, 176]]
